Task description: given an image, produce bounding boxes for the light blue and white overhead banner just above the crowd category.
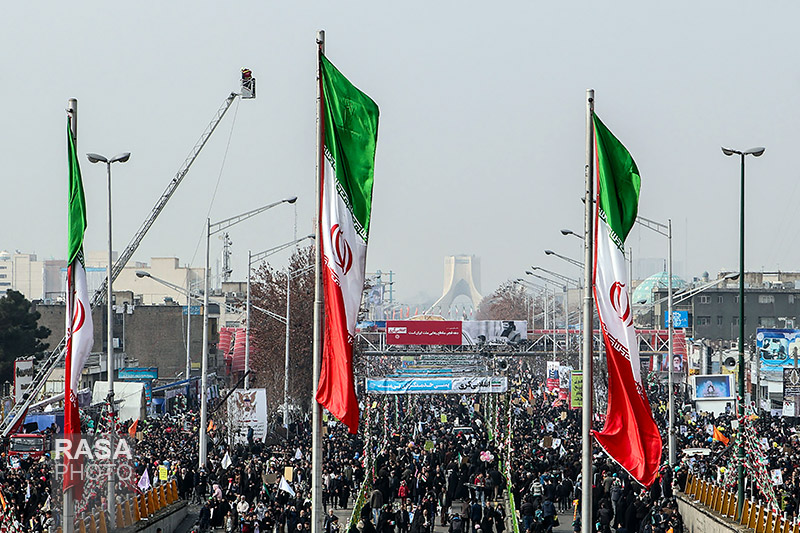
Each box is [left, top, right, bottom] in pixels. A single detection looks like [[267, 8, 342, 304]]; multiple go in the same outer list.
[[366, 376, 508, 394]]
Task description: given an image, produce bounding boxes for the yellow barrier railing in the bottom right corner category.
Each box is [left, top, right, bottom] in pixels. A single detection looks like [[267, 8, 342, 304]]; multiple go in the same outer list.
[[684, 474, 800, 533]]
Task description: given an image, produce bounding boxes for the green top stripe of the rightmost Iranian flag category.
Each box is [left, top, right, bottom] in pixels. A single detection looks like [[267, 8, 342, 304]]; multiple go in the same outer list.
[[593, 115, 641, 246]]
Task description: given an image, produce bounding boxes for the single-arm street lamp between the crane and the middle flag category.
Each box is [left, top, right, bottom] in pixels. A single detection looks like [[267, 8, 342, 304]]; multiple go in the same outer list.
[[198, 196, 297, 468]]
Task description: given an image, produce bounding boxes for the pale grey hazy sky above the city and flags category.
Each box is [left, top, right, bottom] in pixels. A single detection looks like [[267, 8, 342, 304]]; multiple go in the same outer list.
[[0, 0, 800, 303]]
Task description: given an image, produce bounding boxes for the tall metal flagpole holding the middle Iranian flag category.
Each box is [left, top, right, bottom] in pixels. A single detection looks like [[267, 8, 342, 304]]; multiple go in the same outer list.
[[311, 30, 325, 533]]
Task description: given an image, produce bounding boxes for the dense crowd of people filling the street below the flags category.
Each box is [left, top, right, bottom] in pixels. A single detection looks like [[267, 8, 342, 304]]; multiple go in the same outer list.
[[12, 359, 788, 533]]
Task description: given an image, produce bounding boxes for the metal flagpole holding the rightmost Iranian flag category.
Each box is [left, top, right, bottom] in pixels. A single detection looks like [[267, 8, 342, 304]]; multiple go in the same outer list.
[[581, 89, 594, 533]]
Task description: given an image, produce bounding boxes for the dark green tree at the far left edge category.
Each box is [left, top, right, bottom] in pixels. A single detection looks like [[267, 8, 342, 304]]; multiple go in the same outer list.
[[0, 290, 50, 382]]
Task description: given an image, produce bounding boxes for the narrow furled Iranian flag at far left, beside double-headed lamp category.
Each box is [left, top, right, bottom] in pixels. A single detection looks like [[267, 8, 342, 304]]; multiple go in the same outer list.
[[64, 119, 94, 499]]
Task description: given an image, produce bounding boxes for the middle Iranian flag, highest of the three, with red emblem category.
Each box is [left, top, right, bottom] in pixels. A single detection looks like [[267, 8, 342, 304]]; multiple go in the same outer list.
[[317, 53, 378, 433]]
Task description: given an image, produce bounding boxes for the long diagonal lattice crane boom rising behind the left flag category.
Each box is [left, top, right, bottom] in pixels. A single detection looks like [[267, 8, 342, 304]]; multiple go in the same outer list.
[[0, 88, 244, 437]]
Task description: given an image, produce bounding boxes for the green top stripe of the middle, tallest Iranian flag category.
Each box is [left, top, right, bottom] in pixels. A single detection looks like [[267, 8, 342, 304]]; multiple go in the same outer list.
[[320, 54, 378, 242]]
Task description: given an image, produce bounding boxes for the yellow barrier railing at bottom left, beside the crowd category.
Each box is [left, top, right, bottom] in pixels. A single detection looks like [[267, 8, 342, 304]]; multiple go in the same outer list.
[[58, 479, 178, 533]]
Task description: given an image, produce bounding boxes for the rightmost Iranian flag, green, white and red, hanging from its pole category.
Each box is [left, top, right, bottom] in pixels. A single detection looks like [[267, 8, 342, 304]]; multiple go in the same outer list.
[[593, 115, 662, 487]]
